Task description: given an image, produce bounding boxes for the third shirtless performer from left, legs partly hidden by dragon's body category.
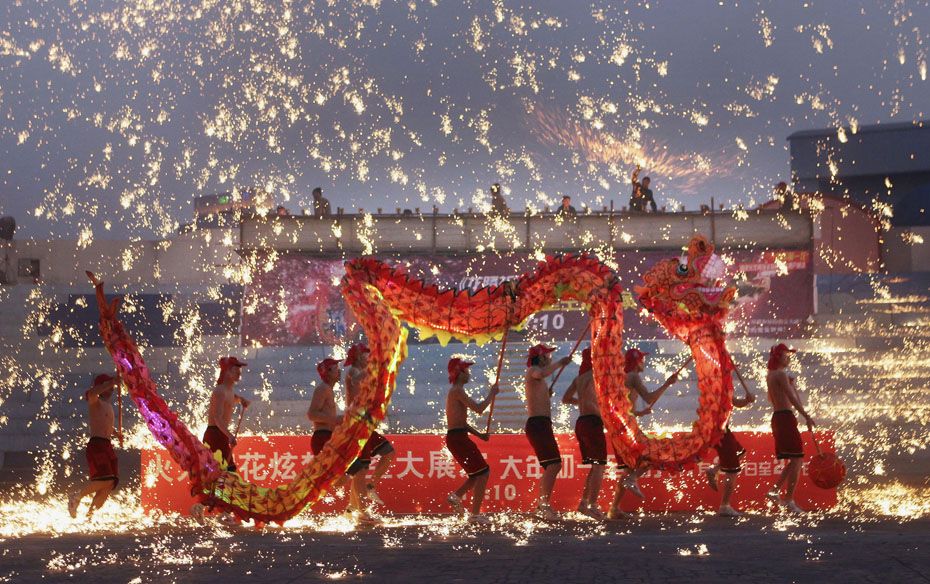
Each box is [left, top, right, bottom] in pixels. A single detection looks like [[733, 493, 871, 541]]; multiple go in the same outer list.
[[307, 358, 371, 522]]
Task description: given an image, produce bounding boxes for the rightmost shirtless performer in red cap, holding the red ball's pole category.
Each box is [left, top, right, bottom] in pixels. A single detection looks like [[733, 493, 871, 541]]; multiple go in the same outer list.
[[765, 343, 815, 513]]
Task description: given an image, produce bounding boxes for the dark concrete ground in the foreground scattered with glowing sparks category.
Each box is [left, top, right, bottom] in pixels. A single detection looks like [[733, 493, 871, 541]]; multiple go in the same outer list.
[[0, 514, 930, 584]]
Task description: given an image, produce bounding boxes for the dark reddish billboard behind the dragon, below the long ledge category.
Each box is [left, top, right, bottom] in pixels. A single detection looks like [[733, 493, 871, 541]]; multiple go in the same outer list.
[[241, 250, 814, 346]]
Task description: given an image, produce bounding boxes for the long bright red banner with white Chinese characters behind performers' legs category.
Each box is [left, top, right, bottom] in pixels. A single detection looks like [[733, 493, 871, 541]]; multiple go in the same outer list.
[[142, 432, 836, 514]]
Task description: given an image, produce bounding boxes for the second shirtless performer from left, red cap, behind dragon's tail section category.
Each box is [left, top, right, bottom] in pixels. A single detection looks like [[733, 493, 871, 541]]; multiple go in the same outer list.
[[191, 357, 252, 523]]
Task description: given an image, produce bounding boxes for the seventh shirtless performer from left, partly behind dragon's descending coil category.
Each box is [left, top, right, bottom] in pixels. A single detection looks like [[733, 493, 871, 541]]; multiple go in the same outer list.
[[562, 347, 607, 521]]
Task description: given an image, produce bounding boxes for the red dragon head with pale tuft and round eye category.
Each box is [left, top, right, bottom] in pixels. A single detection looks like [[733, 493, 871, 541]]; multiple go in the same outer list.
[[634, 235, 736, 340]]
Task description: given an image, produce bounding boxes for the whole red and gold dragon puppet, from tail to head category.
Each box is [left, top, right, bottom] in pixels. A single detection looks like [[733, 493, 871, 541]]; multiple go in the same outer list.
[[89, 236, 735, 523]]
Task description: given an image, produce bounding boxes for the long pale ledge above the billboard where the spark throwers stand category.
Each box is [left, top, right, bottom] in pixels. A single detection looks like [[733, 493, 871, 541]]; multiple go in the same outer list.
[[240, 207, 813, 255]]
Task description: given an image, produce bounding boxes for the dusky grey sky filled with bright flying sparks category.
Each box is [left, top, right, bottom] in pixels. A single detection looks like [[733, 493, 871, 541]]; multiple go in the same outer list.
[[0, 0, 930, 237]]
